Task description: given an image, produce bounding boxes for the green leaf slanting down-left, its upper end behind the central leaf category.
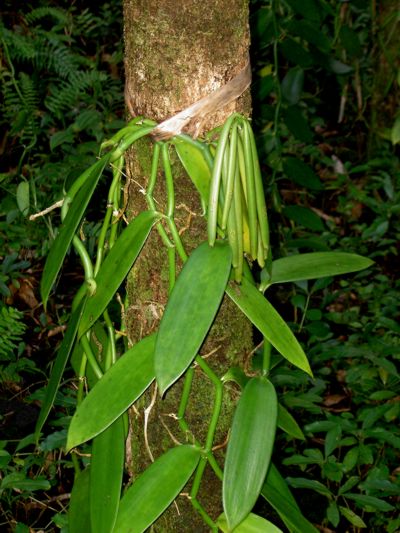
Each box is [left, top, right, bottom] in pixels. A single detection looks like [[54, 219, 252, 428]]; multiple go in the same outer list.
[[67, 335, 155, 450]]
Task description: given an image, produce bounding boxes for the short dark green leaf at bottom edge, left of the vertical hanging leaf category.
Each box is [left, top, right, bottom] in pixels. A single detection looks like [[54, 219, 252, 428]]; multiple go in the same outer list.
[[68, 468, 92, 533]]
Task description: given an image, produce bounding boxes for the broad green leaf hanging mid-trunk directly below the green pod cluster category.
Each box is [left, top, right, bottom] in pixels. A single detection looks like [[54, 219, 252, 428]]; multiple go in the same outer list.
[[154, 242, 232, 394]]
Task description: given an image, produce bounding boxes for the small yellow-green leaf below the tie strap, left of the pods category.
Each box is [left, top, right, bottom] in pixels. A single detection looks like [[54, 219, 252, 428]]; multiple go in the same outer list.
[[174, 138, 211, 205]]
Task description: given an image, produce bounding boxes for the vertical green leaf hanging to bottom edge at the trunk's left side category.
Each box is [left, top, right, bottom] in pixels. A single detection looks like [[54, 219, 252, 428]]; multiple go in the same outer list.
[[89, 417, 125, 533]]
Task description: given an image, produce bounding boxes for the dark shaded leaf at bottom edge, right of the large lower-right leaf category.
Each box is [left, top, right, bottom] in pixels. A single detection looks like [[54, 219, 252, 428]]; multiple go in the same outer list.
[[261, 464, 318, 533]]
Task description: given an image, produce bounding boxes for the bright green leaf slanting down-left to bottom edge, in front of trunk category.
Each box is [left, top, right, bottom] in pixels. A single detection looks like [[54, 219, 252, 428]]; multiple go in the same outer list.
[[114, 445, 200, 533]]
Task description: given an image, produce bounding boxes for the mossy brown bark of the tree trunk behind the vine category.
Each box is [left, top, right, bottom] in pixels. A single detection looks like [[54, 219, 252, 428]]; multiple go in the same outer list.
[[124, 0, 252, 533]]
